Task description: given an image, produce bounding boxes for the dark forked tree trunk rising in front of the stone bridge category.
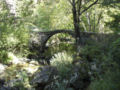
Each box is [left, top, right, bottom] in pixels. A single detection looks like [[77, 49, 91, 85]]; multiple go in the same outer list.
[[69, 0, 99, 51]]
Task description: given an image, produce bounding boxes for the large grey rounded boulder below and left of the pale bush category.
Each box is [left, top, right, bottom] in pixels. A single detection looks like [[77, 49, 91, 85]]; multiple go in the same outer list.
[[31, 66, 58, 90]]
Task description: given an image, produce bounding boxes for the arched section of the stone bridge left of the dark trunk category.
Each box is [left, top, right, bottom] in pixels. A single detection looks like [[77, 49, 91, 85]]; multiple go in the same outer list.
[[30, 30, 75, 52]]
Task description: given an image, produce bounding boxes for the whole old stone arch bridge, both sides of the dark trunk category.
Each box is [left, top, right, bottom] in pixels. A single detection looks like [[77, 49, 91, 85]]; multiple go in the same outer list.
[[29, 30, 110, 52]]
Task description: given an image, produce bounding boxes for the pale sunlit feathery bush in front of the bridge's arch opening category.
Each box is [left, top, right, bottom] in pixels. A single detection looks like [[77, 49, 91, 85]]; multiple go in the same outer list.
[[50, 52, 73, 78]]
